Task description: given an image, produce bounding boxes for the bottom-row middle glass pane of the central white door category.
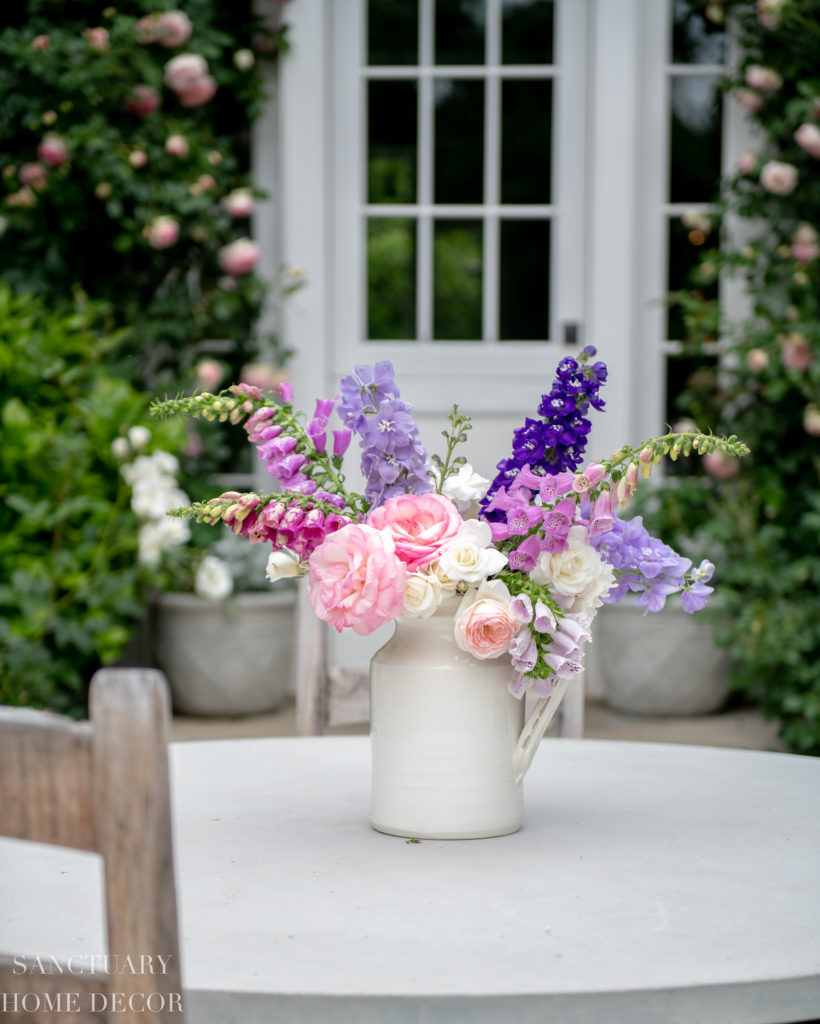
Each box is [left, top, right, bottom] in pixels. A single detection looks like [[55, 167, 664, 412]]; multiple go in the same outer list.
[[433, 220, 482, 341]]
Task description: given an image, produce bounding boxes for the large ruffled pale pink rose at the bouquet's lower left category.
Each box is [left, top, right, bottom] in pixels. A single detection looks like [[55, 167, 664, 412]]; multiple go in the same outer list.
[[309, 523, 406, 636]]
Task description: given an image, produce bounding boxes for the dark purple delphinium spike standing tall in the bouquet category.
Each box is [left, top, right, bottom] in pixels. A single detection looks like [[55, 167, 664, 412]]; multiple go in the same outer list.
[[481, 345, 606, 520]]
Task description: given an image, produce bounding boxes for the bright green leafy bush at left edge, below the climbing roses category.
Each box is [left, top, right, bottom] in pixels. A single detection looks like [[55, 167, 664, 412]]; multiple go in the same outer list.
[[0, 285, 180, 715]]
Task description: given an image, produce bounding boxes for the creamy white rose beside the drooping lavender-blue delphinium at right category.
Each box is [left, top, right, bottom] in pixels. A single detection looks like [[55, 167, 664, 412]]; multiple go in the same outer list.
[[530, 525, 615, 614]]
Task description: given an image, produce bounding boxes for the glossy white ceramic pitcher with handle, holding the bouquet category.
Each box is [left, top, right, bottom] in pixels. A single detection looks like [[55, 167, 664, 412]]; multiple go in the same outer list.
[[371, 598, 566, 839]]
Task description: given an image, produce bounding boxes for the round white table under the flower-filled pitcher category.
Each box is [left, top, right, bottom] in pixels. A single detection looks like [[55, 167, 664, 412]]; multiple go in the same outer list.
[[0, 736, 820, 1024]]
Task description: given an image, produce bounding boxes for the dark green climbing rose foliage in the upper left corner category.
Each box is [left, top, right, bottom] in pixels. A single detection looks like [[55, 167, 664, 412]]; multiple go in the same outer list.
[[0, 0, 284, 388]]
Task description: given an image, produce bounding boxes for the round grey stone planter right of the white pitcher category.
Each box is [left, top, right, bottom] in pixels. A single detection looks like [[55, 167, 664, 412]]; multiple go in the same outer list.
[[587, 596, 729, 716]]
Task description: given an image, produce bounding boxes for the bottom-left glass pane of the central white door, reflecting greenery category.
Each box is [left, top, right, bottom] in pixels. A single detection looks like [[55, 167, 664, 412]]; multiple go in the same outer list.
[[366, 217, 416, 341]]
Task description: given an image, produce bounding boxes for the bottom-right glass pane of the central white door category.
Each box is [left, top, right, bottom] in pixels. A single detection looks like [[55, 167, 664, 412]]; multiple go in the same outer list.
[[499, 220, 550, 341]]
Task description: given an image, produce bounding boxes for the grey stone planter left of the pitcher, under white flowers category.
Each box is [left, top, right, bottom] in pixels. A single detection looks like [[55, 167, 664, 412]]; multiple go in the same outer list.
[[154, 590, 296, 716]]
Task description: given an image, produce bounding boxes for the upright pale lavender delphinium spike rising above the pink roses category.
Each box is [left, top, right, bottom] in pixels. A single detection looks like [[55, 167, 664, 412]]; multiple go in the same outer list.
[[338, 359, 433, 508]]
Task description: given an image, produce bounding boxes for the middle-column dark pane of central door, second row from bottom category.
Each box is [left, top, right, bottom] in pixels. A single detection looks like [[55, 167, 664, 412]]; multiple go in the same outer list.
[[434, 78, 484, 203]]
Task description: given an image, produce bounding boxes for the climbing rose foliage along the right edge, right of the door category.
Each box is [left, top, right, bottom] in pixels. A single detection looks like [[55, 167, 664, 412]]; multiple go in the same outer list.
[[646, 0, 820, 755]]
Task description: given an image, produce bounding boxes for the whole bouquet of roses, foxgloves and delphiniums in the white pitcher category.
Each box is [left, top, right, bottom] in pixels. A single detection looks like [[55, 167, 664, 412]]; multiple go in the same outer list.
[[154, 347, 747, 697]]
